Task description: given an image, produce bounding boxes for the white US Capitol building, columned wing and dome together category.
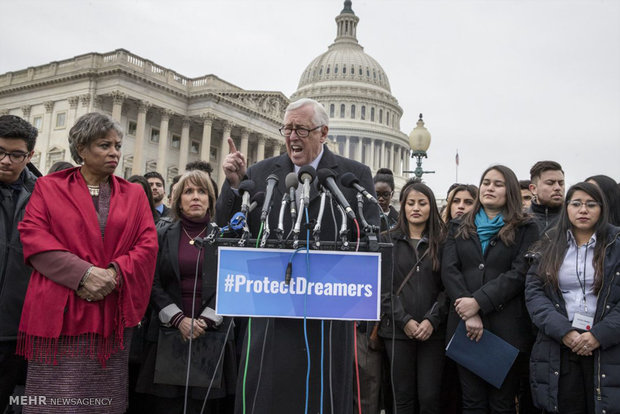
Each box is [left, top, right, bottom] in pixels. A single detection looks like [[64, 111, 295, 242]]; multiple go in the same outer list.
[[0, 1, 416, 188]]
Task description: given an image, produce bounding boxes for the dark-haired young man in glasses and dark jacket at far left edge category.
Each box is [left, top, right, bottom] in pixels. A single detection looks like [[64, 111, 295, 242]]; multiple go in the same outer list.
[[0, 115, 38, 412]]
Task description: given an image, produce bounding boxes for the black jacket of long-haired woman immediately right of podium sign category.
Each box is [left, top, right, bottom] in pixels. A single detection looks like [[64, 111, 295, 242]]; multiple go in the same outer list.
[[379, 230, 449, 340]]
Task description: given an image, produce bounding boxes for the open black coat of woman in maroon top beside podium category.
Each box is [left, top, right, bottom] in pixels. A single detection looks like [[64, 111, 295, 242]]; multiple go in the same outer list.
[[137, 221, 236, 398]]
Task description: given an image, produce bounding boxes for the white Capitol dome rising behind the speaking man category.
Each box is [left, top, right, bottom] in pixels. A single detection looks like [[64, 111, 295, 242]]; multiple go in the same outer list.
[[291, 0, 409, 187]]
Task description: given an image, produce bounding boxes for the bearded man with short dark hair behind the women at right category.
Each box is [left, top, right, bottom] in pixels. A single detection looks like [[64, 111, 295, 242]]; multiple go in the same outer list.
[[529, 161, 564, 235]]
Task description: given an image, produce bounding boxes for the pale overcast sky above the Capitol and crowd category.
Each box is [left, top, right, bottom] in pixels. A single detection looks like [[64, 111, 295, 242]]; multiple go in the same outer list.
[[0, 0, 620, 197]]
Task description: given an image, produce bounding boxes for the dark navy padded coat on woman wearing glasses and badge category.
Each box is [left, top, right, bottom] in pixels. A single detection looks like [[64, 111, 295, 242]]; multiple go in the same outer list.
[[525, 225, 620, 414]]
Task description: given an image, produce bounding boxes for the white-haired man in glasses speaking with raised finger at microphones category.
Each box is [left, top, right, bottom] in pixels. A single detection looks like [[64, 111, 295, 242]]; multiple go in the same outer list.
[[216, 99, 379, 414]]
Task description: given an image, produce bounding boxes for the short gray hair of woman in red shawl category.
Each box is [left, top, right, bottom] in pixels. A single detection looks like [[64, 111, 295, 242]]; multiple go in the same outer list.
[[69, 112, 123, 164]]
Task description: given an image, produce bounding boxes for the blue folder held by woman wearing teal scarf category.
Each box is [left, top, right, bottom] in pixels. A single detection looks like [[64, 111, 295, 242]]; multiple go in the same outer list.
[[446, 321, 519, 389]]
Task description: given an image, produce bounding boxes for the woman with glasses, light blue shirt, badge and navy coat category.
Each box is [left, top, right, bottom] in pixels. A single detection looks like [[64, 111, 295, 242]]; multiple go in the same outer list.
[[525, 183, 620, 414]]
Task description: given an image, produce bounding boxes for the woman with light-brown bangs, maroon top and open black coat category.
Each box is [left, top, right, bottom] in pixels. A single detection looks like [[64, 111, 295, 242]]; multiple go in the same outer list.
[[137, 170, 236, 414]]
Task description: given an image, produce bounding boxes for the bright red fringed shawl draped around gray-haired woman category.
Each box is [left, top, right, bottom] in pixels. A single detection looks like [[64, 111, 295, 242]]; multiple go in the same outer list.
[[17, 167, 157, 365]]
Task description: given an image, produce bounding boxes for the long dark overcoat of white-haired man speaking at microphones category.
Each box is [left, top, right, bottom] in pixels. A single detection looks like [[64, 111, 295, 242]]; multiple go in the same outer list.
[[216, 146, 379, 414]]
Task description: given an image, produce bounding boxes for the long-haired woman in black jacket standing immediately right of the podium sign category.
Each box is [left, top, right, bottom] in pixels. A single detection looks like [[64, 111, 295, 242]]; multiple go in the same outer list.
[[379, 181, 448, 414]]
